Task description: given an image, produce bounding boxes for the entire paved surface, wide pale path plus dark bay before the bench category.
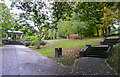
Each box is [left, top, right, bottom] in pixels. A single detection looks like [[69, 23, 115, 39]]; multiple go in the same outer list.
[[0, 45, 114, 75]]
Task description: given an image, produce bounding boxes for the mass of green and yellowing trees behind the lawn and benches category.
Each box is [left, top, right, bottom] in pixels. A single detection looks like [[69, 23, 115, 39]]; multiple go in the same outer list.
[[53, 2, 120, 38]]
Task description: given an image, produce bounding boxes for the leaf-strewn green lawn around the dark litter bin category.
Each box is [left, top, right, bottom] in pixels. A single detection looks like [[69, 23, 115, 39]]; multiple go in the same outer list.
[[31, 36, 119, 67]]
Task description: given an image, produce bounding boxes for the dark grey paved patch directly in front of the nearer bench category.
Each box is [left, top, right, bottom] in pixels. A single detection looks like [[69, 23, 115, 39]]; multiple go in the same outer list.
[[74, 57, 115, 75]]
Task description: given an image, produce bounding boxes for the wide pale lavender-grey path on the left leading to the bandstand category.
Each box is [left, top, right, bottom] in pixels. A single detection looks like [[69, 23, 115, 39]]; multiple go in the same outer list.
[[2, 45, 75, 75]]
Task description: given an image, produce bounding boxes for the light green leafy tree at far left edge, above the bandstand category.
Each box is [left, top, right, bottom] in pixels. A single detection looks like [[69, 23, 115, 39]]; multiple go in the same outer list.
[[0, 3, 17, 35]]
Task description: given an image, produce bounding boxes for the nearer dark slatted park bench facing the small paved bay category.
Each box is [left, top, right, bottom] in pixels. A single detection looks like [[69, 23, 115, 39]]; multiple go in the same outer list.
[[79, 45, 112, 58]]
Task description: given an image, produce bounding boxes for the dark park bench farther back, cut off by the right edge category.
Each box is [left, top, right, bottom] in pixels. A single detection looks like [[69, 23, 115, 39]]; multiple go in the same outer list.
[[100, 38, 120, 45]]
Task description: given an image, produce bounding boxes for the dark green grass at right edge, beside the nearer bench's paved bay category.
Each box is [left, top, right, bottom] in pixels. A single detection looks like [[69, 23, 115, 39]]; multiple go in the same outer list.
[[107, 43, 120, 73]]
